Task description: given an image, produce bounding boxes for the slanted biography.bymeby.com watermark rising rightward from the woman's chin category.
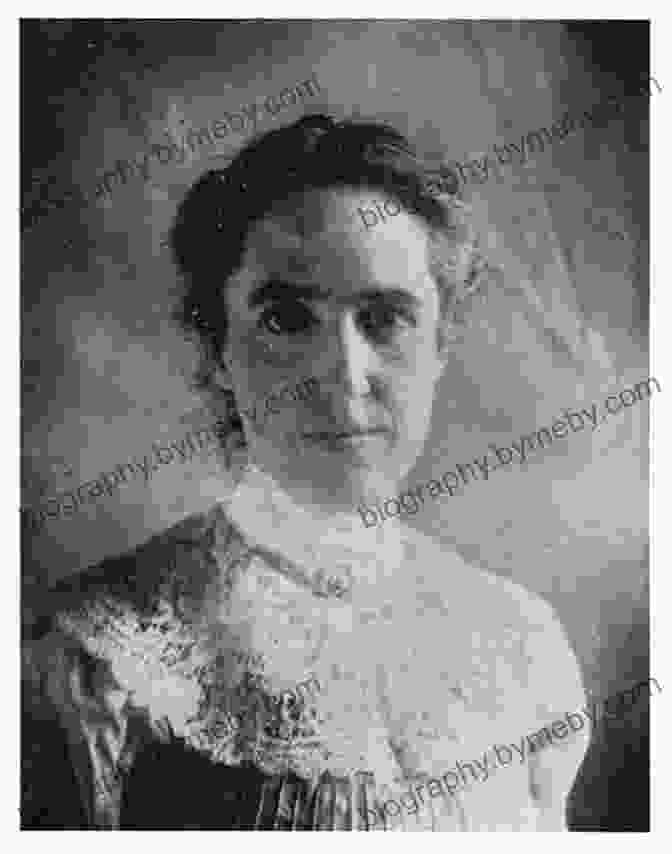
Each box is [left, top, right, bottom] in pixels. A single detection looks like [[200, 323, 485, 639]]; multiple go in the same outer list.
[[357, 377, 660, 528]]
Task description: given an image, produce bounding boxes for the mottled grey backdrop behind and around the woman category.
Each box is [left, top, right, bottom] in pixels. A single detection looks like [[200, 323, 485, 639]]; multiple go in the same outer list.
[[21, 20, 652, 830]]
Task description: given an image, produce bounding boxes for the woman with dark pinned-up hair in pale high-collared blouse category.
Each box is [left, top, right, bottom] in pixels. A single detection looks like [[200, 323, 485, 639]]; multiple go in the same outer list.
[[22, 116, 587, 831]]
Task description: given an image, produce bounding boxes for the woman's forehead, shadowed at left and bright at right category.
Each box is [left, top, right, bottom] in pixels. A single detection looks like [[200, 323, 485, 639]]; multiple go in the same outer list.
[[231, 190, 434, 306]]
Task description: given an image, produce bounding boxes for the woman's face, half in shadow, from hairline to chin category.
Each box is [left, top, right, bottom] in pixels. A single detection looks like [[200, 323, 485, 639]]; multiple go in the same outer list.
[[225, 190, 443, 512]]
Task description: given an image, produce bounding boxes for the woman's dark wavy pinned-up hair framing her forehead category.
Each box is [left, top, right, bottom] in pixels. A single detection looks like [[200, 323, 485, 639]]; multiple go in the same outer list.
[[169, 115, 494, 394]]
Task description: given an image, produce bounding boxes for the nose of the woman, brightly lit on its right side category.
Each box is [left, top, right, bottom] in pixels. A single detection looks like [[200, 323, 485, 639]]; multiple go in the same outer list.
[[322, 311, 379, 397]]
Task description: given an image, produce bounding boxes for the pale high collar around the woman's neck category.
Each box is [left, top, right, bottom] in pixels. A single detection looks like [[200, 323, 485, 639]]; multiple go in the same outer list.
[[226, 465, 403, 592]]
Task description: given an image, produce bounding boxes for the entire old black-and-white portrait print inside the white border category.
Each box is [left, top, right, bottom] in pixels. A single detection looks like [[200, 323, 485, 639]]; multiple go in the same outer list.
[[19, 16, 666, 832]]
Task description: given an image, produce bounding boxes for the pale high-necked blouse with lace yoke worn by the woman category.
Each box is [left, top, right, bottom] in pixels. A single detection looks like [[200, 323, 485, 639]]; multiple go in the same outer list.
[[25, 468, 588, 831]]
